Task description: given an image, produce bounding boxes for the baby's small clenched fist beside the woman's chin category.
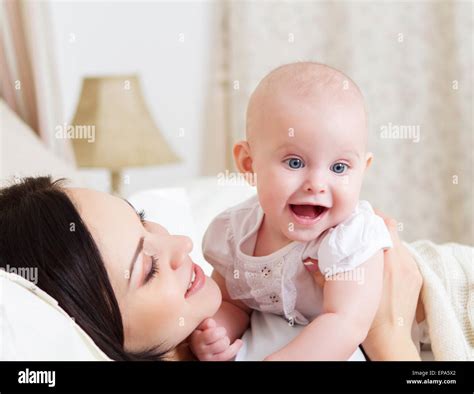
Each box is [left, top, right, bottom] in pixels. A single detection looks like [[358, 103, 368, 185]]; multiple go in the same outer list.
[[190, 319, 243, 361]]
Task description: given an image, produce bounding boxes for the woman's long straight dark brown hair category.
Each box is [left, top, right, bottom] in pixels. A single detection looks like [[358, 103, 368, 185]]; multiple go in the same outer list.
[[0, 177, 189, 360]]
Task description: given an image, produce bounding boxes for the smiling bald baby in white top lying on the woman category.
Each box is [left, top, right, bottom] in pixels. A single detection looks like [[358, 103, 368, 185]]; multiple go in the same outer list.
[[190, 62, 392, 360]]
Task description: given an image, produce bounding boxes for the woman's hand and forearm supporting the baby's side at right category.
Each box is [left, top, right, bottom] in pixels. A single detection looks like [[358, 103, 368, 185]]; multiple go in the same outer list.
[[305, 211, 422, 360]]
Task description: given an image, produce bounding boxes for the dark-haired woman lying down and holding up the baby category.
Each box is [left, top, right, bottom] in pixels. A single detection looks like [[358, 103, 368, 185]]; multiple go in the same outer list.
[[0, 177, 421, 360]]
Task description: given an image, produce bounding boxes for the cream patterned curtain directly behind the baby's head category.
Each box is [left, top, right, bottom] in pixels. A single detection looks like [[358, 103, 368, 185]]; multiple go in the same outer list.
[[222, 1, 474, 244]]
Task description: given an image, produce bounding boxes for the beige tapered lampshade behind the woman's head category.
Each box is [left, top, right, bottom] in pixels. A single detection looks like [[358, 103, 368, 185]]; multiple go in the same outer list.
[[72, 75, 179, 171]]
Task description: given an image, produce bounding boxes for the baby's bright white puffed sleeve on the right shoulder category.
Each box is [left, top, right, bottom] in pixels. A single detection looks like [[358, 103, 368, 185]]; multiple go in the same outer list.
[[318, 201, 392, 276]]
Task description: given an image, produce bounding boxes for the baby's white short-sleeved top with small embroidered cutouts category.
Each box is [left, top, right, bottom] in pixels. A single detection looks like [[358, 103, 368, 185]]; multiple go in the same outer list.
[[203, 196, 392, 324]]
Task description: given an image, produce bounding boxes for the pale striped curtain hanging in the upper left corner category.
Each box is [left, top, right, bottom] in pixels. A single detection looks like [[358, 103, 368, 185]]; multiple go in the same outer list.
[[0, 0, 74, 162]]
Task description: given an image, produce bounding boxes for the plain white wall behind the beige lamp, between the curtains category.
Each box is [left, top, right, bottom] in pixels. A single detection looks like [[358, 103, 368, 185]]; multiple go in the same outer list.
[[51, 1, 216, 195]]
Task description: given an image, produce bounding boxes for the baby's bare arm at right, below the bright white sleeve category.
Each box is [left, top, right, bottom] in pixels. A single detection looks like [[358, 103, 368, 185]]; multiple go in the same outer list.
[[265, 251, 383, 361]]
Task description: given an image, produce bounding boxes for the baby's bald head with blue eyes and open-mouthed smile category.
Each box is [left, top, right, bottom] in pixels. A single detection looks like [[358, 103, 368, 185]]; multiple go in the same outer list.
[[233, 63, 372, 244]]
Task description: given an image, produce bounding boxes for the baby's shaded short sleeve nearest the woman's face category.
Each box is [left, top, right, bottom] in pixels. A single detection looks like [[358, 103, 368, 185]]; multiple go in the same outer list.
[[202, 211, 234, 278]]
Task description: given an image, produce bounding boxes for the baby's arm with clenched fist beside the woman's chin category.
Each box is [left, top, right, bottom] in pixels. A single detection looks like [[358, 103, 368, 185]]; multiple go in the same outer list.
[[190, 270, 250, 361]]
